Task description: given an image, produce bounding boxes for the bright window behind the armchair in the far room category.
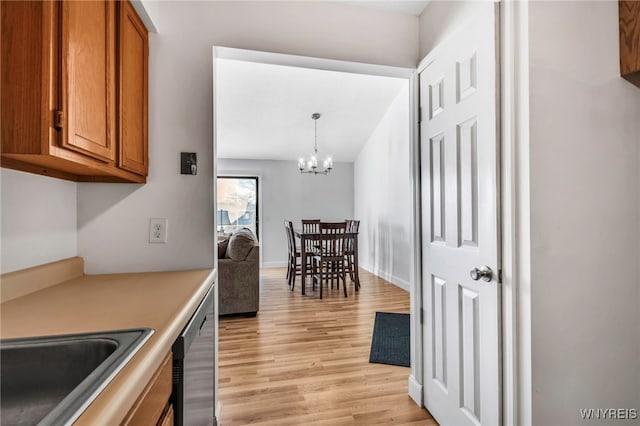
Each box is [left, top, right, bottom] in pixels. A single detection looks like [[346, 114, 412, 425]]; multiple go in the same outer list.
[[216, 176, 260, 238]]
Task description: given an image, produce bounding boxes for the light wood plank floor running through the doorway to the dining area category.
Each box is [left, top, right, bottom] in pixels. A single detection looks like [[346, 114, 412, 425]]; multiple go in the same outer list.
[[219, 268, 437, 426]]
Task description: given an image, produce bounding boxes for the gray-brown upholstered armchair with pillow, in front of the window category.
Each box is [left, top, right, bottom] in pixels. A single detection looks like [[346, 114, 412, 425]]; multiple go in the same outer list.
[[218, 229, 260, 315]]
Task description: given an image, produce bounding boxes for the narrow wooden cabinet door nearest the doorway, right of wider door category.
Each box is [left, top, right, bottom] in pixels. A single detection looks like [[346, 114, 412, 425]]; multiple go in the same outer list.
[[118, 1, 149, 176]]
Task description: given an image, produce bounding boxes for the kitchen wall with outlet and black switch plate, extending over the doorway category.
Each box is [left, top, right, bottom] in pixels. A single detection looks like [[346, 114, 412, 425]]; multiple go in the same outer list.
[[78, 1, 418, 273]]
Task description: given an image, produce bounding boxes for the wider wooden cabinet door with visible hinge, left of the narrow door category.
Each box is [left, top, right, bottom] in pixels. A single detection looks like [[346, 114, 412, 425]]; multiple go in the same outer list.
[[60, 1, 116, 162]]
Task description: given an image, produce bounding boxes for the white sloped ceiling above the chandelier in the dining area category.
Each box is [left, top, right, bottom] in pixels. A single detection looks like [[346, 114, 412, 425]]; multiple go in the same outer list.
[[216, 59, 407, 162]]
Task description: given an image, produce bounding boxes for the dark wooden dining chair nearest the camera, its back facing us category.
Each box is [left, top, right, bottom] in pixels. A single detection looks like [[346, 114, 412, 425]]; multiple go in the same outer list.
[[312, 222, 347, 299]]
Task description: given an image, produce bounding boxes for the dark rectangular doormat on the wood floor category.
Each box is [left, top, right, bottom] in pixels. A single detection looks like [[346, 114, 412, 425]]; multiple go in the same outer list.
[[369, 312, 411, 367]]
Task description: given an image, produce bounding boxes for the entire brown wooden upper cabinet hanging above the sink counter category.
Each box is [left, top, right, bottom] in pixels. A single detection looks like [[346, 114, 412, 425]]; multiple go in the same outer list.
[[0, 0, 149, 183]]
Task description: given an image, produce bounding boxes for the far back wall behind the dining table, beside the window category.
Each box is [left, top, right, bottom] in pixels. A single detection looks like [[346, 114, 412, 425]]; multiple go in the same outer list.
[[218, 159, 353, 268]]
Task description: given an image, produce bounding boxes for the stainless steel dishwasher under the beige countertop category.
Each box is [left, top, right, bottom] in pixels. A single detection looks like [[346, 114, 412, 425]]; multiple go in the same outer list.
[[171, 286, 215, 426]]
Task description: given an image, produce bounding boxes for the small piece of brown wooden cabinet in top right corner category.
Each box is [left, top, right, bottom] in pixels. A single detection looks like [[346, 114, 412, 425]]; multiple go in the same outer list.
[[618, 0, 640, 87]]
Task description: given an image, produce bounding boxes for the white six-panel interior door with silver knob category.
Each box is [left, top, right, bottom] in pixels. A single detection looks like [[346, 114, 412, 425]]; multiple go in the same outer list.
[[420, 2, 501, 425]]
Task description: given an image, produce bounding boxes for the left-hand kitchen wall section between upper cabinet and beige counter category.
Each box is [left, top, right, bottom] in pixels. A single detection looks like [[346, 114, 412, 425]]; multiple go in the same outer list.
[[0, 169, 78, 273]]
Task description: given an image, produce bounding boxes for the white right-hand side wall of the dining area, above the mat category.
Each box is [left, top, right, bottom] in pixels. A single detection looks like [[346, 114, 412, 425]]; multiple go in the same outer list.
[[354, 82, 412, 291]]
